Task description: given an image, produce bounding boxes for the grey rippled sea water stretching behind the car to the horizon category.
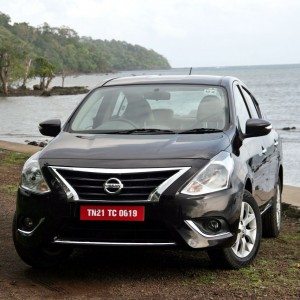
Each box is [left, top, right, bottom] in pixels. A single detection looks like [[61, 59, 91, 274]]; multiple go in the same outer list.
[[0, 64, 300, 186]]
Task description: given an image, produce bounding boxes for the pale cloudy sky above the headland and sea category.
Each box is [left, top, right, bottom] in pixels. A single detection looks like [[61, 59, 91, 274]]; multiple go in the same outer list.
[[0, 0, 300, 67]]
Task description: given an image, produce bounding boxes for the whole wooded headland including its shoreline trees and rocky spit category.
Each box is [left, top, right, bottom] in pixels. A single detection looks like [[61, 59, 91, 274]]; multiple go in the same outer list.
[[0, 12, 170, 96]]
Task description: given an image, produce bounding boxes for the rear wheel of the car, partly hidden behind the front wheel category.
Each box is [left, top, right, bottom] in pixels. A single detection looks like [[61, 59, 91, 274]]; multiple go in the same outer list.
[[262, 183, 282, 238]]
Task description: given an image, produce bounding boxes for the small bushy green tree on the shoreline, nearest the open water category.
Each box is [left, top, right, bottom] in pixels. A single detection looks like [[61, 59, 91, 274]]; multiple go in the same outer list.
[[34, 57, 55, 91]]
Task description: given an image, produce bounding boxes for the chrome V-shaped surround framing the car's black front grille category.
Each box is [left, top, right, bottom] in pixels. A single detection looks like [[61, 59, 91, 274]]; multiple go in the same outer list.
[[49, 166, 191, 203]]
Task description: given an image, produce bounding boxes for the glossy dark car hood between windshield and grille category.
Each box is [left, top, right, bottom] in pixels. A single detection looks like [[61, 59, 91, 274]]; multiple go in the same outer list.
[[40, 132, 229, 160]]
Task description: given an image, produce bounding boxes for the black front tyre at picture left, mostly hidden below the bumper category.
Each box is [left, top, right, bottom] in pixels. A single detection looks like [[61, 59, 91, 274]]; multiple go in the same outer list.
[[13, 215, 72, 269]]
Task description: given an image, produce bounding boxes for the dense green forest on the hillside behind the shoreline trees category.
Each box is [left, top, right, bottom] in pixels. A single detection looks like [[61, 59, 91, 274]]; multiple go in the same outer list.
[[0, 12, 170, 80]]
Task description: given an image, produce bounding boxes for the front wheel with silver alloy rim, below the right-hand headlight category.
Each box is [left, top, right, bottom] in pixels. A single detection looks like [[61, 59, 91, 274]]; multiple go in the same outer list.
[[207, 191, 262, 269]]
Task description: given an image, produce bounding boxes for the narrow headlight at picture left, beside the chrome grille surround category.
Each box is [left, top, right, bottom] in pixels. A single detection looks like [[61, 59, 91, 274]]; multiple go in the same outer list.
[[21, 153, 50, 194]]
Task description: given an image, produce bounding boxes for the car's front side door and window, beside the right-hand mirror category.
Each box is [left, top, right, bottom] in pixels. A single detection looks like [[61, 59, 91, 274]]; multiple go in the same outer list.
[[233, 82, 267, 206]]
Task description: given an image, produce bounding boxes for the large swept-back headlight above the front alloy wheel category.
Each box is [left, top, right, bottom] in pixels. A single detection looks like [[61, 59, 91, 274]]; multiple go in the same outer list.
[[181, 152, 234, 196]]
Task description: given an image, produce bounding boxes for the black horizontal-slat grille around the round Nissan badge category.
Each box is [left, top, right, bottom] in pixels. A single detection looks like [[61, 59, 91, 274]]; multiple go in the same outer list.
[[56, 168, 179, 201]]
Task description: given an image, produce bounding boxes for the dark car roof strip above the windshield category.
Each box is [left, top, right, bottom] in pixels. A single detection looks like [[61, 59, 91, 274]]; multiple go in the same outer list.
[[103, 75, 237, 86]]
